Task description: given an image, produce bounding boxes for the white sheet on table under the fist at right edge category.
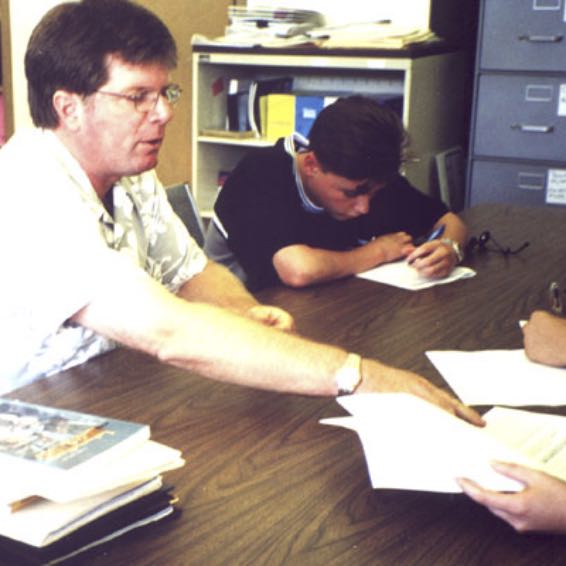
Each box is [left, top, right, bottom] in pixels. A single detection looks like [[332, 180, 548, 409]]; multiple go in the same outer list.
[[426, 350, 566, 406]]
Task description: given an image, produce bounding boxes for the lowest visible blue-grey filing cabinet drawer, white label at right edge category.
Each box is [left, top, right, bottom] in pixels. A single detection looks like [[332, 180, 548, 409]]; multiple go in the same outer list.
[[469, 160, 566, 206]]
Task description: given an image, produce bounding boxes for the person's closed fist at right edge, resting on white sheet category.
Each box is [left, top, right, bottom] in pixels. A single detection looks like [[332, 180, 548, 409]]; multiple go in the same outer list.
[[523, 311, 566, 367]]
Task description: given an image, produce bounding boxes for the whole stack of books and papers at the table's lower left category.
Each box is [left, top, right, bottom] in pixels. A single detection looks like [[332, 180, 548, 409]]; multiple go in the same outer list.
[[0, 399, 184, 564]]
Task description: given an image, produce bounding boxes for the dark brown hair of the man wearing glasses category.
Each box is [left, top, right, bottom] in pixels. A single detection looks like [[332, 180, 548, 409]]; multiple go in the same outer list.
[[25, 0, 177, 128]]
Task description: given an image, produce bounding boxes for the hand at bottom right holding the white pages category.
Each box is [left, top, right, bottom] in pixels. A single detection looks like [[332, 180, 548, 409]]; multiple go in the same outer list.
[[457, 462, 566, 533]]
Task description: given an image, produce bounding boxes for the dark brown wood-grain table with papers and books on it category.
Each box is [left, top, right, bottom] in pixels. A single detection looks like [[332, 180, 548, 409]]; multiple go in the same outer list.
[[13, 205, 566, 566]]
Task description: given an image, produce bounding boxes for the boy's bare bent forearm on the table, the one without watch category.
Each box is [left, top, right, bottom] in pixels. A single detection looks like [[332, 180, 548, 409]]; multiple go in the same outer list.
[[273, 232, 414, 287]]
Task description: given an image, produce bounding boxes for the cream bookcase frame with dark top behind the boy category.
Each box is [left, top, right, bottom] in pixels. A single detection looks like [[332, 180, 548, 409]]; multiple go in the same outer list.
[[191, 46, 468, 216]]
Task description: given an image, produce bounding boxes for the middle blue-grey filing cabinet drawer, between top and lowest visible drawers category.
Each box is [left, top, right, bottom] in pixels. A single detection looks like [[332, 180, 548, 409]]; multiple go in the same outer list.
[[474, 73, 566, 161]]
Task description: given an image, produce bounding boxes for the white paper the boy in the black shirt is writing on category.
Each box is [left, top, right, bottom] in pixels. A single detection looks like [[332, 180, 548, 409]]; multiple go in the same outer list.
[[358, 259, 476, 291]]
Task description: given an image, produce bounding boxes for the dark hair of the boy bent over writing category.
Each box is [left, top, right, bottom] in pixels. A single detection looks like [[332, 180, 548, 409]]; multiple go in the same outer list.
[[309, 96, 406, 182]]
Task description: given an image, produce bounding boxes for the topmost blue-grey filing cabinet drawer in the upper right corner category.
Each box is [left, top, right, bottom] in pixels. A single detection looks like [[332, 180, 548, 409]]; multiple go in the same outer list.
[[480, 0, 566, 71]]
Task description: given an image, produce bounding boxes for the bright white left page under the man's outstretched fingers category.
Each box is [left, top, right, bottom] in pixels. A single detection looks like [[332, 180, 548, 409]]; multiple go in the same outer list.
[[321, 393, 524, 493]]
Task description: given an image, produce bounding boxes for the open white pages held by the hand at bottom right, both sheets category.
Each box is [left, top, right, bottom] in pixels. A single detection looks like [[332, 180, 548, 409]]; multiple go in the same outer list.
[[320, 393, 566, 493]]
